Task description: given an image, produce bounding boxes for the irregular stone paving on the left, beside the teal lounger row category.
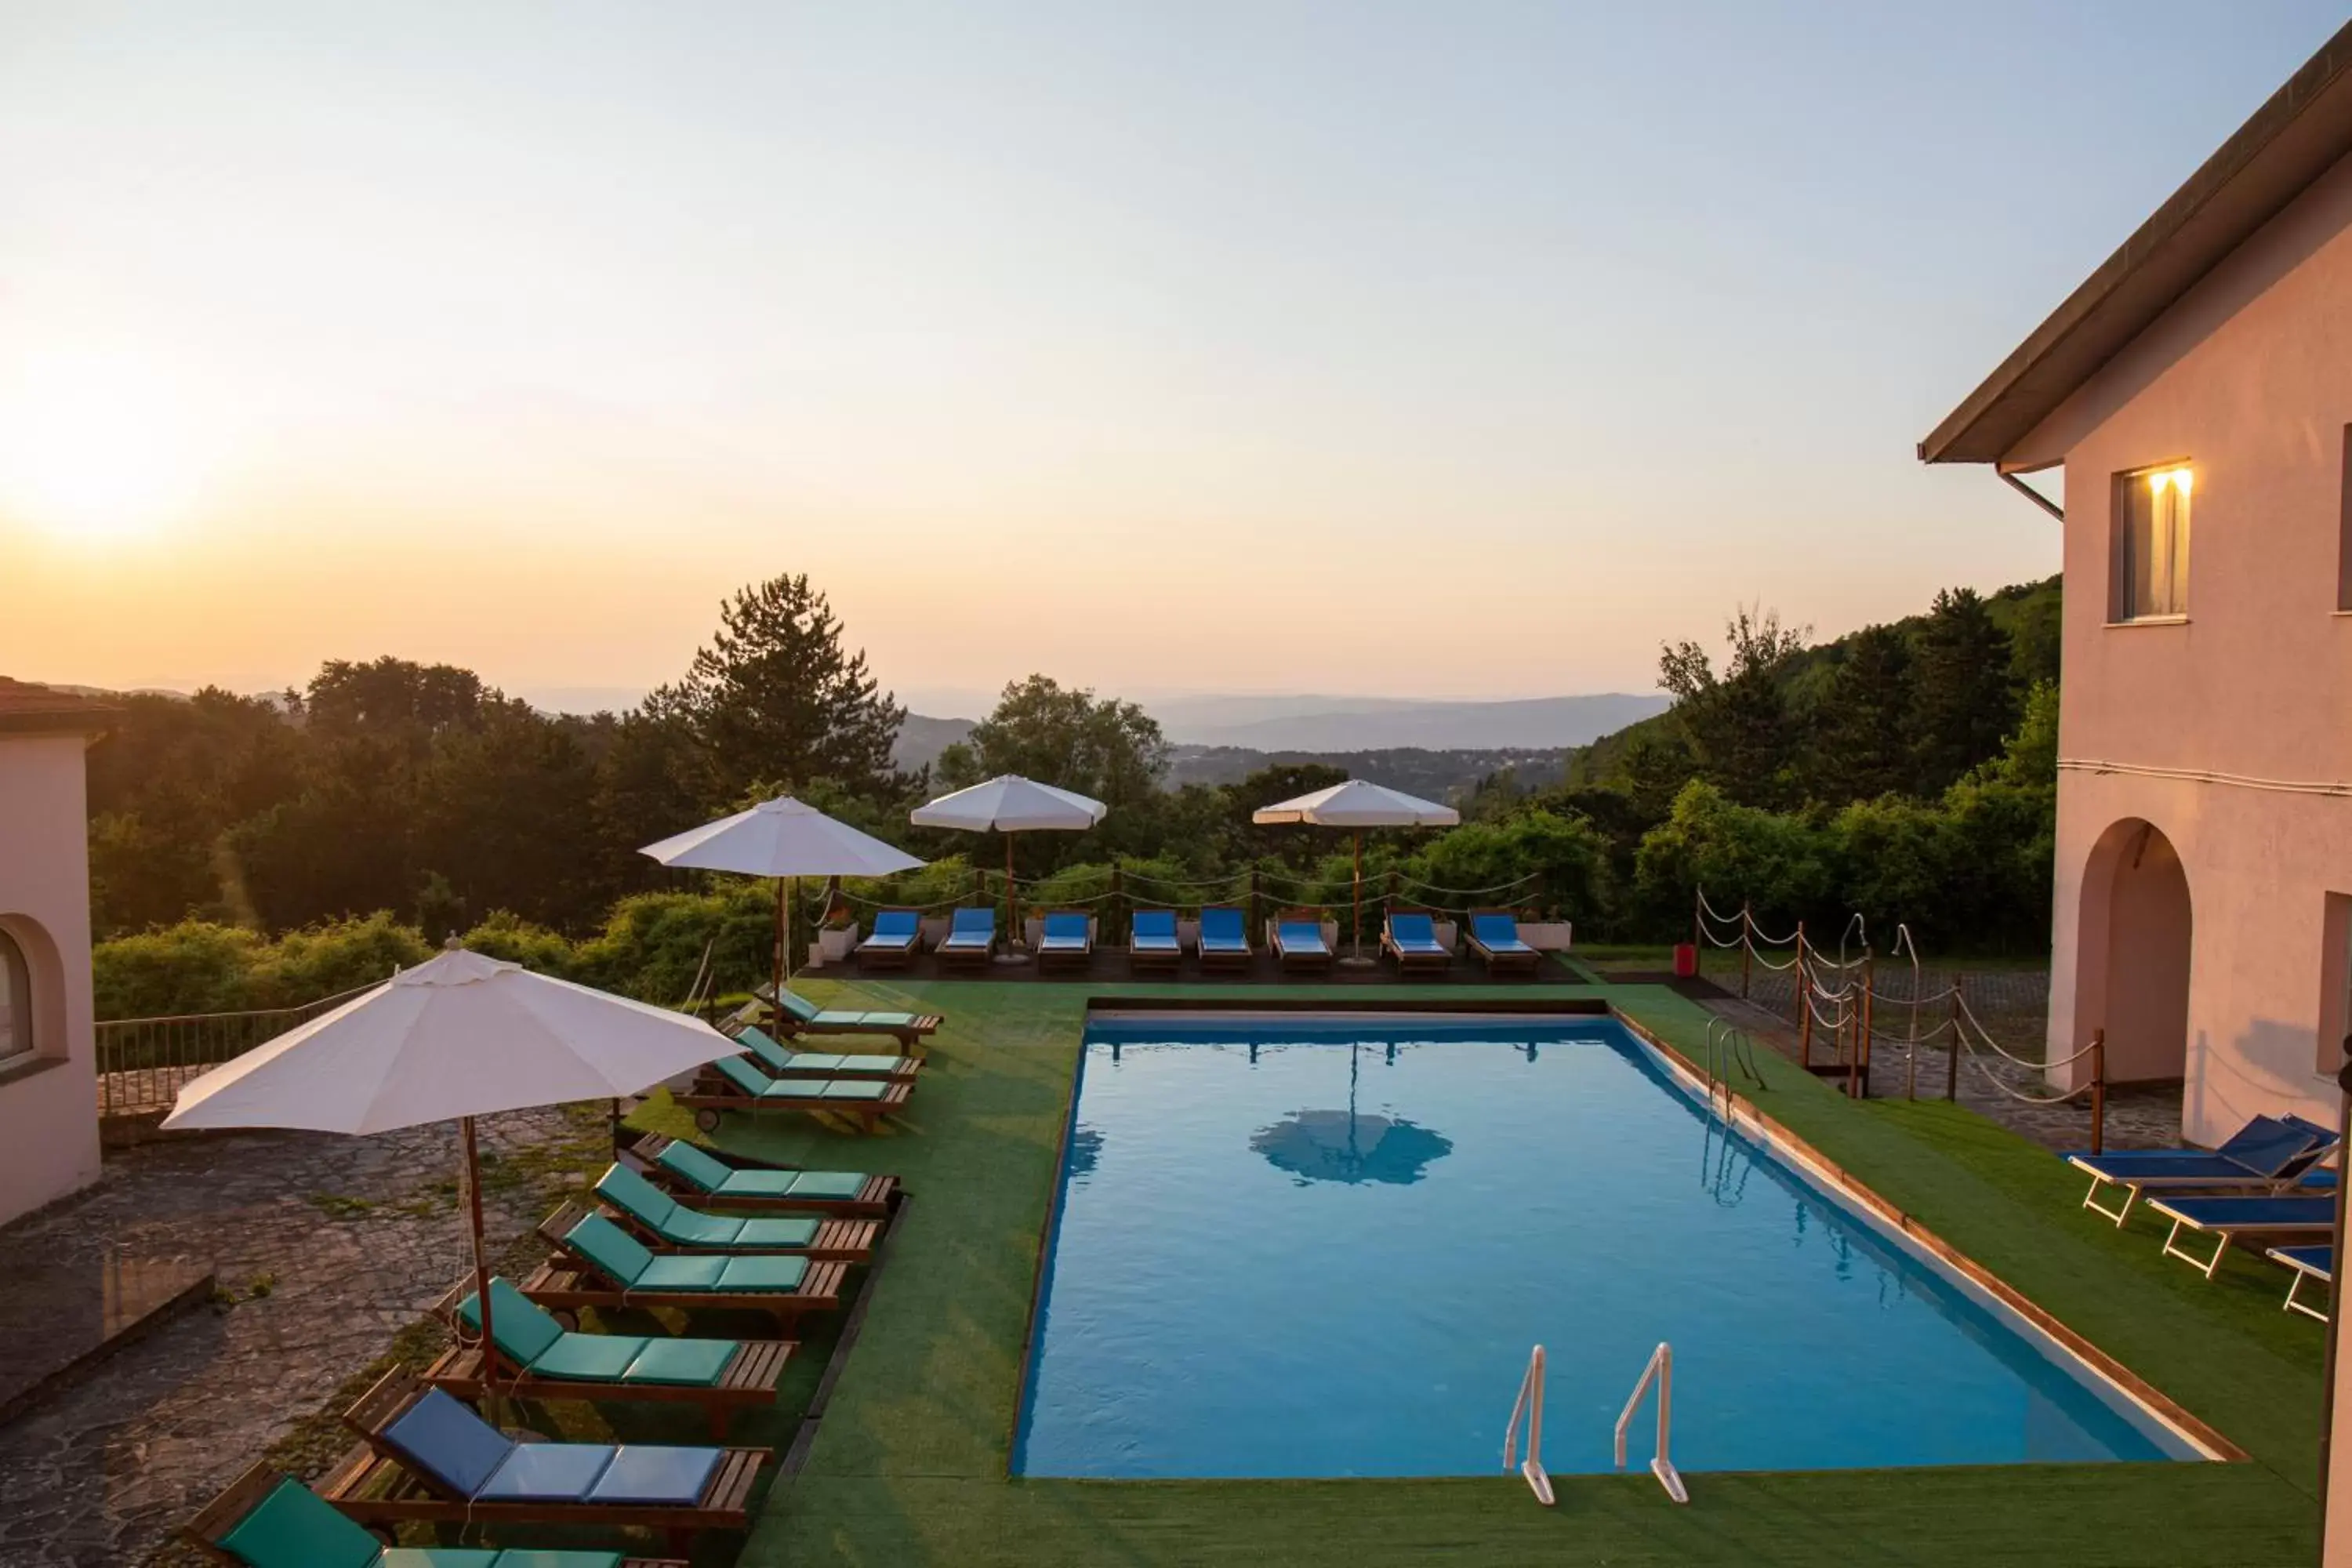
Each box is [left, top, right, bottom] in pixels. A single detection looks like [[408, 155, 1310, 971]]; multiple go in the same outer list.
[[0, 1109, 597, 1568]]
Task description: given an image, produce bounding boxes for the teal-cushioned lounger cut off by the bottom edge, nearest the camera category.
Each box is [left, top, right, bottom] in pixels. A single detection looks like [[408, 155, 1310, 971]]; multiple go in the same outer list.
[[188, 1462, 687, 1568]]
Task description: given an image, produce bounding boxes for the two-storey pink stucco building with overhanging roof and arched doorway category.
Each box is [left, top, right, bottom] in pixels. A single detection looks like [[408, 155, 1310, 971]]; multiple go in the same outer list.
[[1919, 28, 2352, 1142]]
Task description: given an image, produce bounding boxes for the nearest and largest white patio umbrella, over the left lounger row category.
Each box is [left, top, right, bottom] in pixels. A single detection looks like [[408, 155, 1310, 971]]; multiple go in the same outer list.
[[165, 947, 739, 1385]]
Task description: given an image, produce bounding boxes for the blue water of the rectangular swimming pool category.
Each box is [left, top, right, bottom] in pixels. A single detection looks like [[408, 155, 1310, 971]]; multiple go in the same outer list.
[[1014, 1018, 2194, 1476]]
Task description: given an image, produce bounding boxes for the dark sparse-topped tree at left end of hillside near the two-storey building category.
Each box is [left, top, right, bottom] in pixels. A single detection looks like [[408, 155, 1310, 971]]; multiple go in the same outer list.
[[1658, 604, 1811, 806]]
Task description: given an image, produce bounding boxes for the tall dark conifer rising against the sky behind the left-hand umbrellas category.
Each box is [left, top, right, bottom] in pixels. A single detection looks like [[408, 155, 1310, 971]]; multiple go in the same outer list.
[[682, 574, 906, 797]]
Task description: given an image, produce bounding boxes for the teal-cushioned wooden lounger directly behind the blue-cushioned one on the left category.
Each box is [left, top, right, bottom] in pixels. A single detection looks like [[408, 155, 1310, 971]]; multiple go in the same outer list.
[[426, 1276, 797, 1439]]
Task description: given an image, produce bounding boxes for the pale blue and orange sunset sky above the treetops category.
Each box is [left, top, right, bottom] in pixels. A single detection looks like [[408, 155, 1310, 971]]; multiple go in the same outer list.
[[0, 0, 2340, 713]]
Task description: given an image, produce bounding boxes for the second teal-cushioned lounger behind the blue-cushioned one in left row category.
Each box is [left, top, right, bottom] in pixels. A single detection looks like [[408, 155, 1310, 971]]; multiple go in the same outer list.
[[522, 1203, 849, 1328]]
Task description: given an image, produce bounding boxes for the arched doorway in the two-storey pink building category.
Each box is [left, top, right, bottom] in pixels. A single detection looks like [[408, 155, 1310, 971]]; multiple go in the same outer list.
[[2074, 818, 2192, 1083]]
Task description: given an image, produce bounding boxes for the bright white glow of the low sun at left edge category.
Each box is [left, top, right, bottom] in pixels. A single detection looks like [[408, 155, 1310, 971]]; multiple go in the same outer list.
[[0, 353, 207, 543]]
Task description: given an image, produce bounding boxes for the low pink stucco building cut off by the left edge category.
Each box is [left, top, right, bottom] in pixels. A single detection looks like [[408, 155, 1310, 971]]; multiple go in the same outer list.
[[0, 677, 113, 1222]]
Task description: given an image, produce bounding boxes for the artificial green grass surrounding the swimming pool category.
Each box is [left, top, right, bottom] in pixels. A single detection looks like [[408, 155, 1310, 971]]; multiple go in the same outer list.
[[642, 982, 2319, 1568]]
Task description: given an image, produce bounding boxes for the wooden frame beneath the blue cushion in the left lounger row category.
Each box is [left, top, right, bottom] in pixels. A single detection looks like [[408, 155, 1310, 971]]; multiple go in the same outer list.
[[320, 1368, 776, 1554]]
